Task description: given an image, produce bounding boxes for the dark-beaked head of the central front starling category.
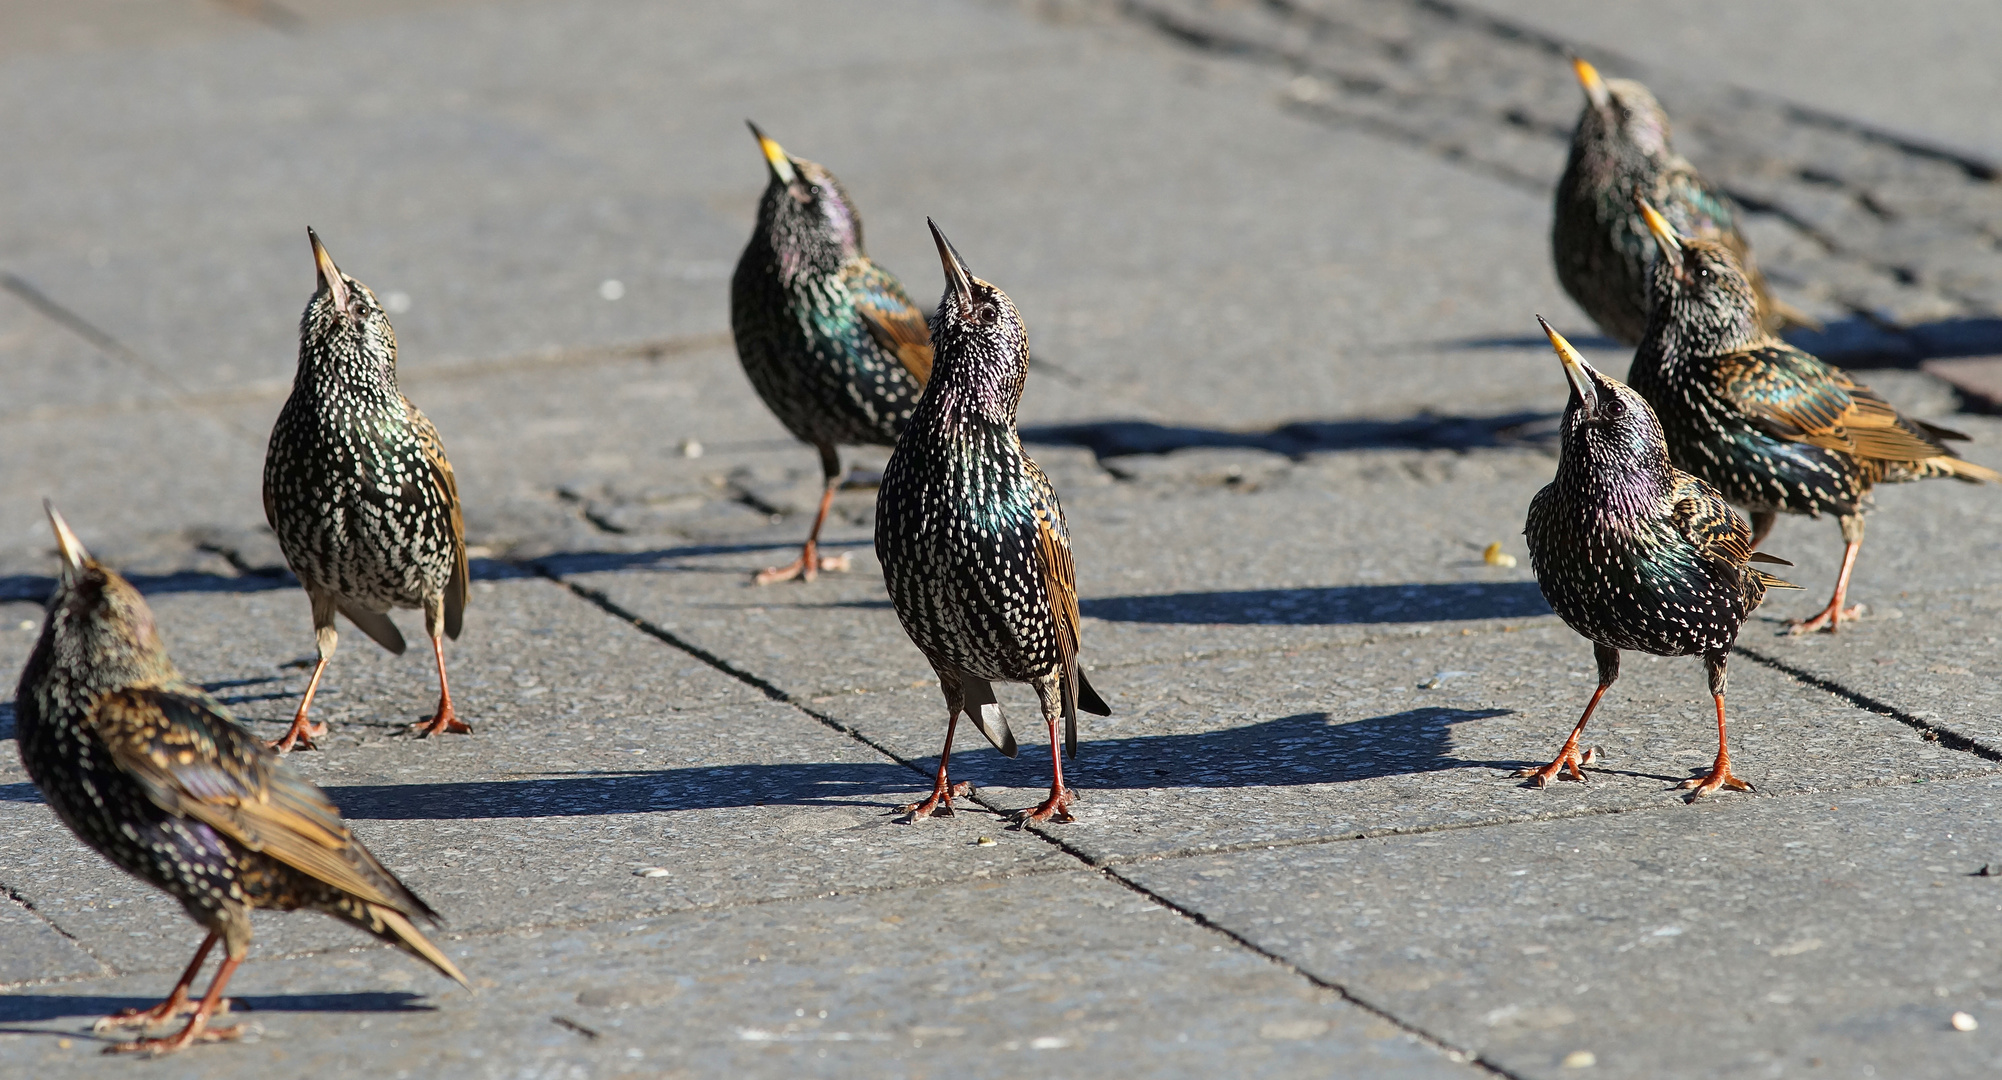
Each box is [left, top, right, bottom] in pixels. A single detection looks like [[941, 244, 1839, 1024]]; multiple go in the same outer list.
[[925, 218, 1029, 423]]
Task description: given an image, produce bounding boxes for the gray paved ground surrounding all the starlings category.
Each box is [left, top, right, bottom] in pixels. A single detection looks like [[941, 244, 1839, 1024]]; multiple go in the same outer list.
[[0, 0, 2002, 1078]]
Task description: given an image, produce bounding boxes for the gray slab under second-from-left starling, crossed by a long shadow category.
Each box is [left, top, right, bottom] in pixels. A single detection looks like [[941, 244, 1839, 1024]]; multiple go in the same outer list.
[[0, 579, 1067, 970]]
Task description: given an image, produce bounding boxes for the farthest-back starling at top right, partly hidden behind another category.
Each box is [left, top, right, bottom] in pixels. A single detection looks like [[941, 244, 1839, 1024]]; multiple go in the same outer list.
[[1550, 58, 1814, 345]]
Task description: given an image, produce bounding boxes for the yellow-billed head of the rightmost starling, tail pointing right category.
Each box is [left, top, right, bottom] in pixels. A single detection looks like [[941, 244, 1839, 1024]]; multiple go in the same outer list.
[[1638, 200, 1766, 357]]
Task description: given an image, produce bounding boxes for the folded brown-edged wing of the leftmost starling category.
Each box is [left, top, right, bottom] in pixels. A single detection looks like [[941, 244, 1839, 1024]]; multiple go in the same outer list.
[[90, 687, 434, 918]]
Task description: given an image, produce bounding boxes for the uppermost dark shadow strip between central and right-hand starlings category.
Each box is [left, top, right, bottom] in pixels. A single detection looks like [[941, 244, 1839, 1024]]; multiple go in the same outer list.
[[1021, 413, 1560, 459]]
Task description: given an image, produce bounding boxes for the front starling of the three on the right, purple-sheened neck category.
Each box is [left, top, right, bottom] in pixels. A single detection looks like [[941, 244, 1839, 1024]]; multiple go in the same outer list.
[[1518, 317, 1794, 801]]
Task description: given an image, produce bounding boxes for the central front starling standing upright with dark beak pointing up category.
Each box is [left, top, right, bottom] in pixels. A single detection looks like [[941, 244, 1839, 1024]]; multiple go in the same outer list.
[[875, 218, 1111, 822]]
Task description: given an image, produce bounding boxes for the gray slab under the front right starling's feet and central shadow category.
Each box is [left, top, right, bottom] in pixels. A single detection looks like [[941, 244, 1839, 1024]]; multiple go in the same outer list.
[[813, 627, 1994, 862]]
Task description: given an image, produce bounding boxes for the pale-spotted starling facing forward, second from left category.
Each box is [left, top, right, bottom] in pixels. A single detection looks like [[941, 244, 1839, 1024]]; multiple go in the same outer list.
[[264, 228, 472, 751]]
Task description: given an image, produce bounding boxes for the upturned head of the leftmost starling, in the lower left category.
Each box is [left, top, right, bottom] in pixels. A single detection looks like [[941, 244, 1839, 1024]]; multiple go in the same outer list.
[[30, 501, 172, 689]]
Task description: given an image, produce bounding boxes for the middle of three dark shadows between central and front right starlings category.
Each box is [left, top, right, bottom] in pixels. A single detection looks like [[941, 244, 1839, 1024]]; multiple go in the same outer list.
[[1079, 581, 1550, 627]]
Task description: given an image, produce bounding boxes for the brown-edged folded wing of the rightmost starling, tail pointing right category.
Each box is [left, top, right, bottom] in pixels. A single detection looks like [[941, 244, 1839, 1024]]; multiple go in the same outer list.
[[1718, 341, 1948, 461]]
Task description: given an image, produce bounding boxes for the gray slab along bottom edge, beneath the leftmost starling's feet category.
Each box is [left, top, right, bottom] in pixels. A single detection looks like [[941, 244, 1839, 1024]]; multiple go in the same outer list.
[[0, 872, 1479, 1078]]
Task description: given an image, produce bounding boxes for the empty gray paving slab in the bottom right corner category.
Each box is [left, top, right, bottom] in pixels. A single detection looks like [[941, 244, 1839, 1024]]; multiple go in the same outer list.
[[1121, 779, 2002, 1078]]
